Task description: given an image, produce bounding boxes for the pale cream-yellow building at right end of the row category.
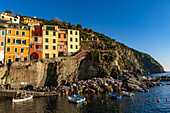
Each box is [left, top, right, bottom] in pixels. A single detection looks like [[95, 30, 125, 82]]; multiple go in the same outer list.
[[67, 29, 80, 55]]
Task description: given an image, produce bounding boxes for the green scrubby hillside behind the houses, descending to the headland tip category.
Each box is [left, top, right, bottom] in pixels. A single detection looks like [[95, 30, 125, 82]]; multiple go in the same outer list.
[[20, 15, 164, 74]]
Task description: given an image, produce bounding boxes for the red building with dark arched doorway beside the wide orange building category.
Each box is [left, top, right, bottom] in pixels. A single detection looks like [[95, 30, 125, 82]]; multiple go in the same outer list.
[[30, 26, 43, 59]]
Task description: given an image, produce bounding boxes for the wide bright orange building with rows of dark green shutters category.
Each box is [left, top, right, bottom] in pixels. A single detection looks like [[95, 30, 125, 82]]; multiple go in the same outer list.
[[5, 25, 30, 63]]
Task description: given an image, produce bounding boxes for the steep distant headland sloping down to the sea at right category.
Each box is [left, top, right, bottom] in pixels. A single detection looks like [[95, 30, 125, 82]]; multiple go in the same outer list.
[[117, 42, 164, 74]]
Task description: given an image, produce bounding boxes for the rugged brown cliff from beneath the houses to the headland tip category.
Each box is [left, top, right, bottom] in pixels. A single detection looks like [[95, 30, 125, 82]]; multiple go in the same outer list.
[[0, 43, 164, 88]]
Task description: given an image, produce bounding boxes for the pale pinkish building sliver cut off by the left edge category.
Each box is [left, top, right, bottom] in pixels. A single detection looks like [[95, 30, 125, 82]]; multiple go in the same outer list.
[[0, 27, 5, 65]]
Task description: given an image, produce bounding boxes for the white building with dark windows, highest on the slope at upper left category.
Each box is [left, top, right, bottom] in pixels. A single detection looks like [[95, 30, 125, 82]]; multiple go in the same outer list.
[[0, 12, 20, 24]]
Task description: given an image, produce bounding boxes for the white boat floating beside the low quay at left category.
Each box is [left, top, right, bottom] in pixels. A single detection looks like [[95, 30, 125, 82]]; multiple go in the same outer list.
[[12, 95, 33, 102]]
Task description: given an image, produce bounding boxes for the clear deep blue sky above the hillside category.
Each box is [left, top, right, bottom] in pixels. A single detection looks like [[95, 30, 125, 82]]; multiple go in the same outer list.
[[0, 0, 170, 71]]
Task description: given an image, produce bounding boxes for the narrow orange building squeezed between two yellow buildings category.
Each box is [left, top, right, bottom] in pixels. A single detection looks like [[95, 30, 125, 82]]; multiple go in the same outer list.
[[57, 28, 68, 56]]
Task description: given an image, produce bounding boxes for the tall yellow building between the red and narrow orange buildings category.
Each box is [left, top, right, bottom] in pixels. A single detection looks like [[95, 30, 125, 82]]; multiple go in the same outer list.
[[42, 25, 58, 59]]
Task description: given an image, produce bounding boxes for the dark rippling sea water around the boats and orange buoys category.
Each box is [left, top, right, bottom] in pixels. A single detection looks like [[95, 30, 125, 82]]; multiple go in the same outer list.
[[0, 73, 170, 113]]
